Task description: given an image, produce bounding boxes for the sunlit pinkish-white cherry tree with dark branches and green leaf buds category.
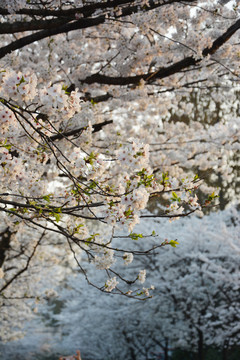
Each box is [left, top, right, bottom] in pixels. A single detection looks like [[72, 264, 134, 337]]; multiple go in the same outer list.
[[0, 0, 240, 342]]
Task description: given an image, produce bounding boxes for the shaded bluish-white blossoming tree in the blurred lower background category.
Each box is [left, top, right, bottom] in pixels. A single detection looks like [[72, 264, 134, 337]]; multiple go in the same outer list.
[[44, 207, 240, 359]]
